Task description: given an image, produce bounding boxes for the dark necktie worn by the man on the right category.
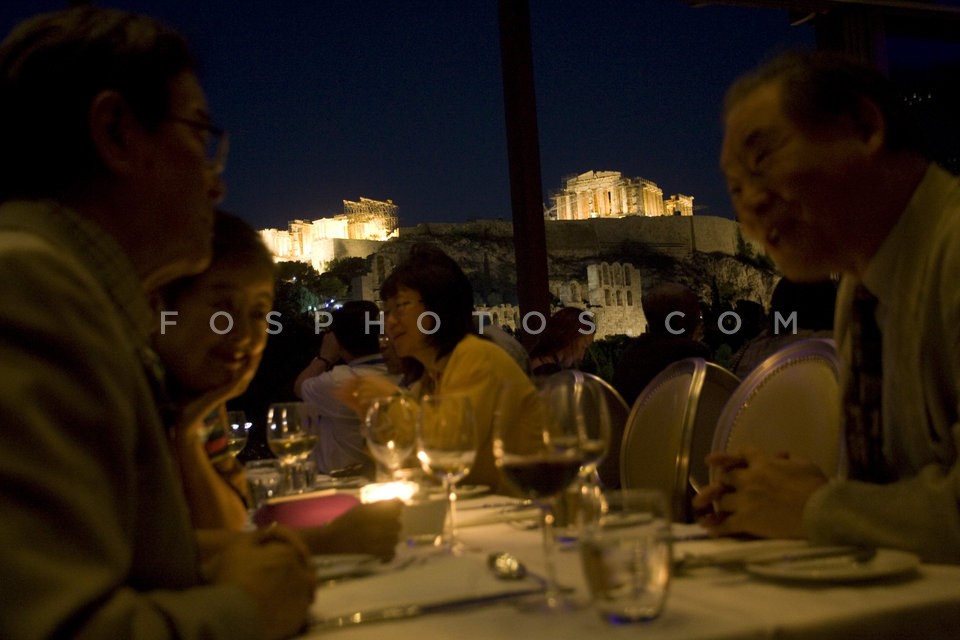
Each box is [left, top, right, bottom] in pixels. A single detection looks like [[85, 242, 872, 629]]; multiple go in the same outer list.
[[844, 284, 891, 483]]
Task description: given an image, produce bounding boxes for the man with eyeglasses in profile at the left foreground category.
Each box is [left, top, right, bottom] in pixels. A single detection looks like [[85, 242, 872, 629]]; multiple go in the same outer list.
[[0, 7, 314, 639]]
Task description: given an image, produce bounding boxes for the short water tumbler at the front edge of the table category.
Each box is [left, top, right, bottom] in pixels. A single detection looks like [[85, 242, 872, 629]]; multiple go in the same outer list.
[[580, 489, 672, 624]]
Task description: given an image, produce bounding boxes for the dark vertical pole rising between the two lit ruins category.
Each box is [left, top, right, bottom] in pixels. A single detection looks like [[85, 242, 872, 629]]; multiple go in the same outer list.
[[499, 0, 550, 346]]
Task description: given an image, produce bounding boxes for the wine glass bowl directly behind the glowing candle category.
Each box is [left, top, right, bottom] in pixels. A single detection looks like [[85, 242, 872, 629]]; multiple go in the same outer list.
[[362, 393, 418, 480]]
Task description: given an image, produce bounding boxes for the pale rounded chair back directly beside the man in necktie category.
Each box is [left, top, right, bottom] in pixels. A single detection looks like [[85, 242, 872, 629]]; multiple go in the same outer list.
[[712, 338, 847, 480]]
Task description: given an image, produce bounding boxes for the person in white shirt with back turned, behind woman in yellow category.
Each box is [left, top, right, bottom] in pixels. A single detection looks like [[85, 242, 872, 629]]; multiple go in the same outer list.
[[293, 300, 399, 477]]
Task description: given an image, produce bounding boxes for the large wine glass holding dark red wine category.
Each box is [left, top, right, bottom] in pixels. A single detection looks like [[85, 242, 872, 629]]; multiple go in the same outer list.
[[493, 372, 599, 611]]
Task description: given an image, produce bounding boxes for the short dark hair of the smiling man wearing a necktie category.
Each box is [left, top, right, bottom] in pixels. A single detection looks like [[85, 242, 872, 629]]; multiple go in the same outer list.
[[724, 51, 921, 151]]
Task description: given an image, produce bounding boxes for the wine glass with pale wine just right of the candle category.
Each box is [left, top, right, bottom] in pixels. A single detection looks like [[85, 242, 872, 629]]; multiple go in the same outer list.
[[417, 393, 478, 553]]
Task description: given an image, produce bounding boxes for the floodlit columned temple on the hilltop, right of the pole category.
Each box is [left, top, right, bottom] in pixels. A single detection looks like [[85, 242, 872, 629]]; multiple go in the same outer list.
[[547, 171, 693, 220]]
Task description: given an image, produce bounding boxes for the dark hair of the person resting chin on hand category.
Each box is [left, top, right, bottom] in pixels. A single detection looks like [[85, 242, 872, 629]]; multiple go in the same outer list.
[[160, 210, 276, 306]]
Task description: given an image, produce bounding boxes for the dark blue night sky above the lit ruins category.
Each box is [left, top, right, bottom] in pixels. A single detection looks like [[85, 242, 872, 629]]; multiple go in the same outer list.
[[0, 0, 960, 228]]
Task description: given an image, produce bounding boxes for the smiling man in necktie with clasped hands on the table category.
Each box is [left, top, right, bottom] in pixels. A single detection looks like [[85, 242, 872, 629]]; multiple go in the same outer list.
[[694, 52, 960, 563]]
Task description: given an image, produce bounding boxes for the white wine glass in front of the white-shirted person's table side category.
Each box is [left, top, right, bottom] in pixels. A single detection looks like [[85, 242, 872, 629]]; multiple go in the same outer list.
[[267, 402, 318, 493]]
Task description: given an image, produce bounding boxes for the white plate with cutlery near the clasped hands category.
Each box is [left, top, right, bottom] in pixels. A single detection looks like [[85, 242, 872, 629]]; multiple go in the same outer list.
[[746, 549, 920, 582]]
